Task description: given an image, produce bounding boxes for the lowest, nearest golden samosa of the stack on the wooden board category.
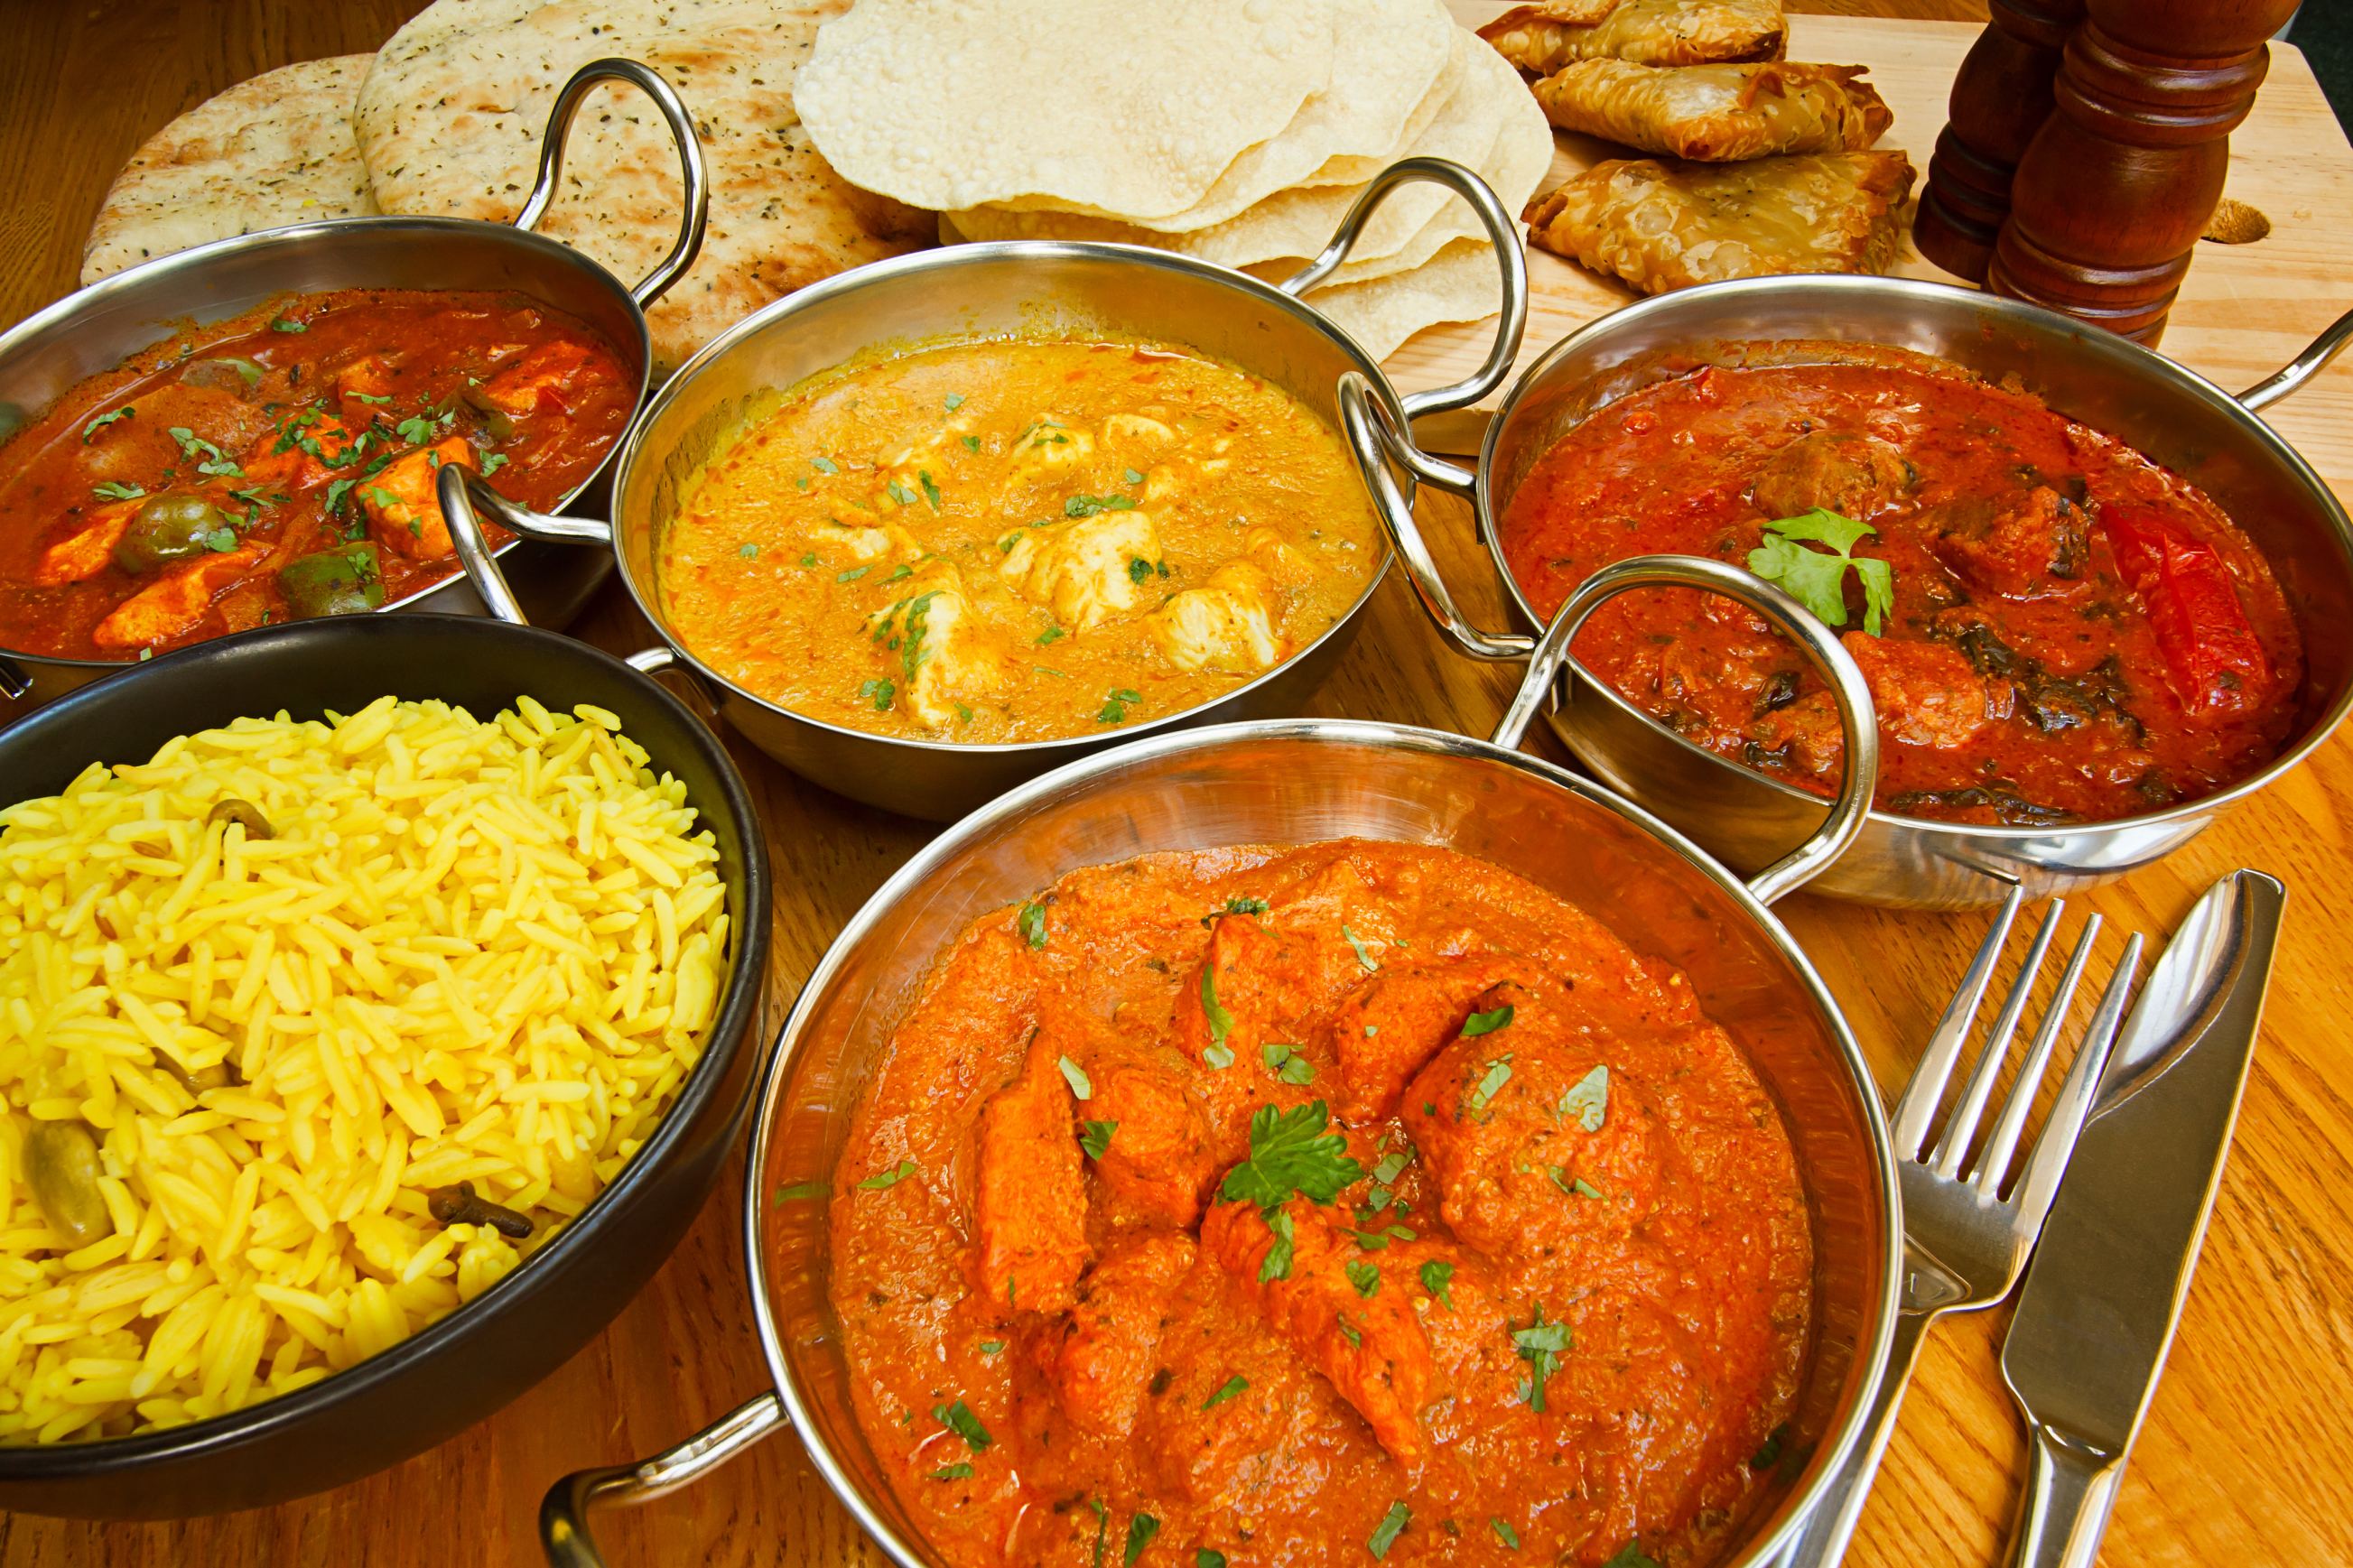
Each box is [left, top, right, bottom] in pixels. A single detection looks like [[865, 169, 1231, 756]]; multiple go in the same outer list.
[[1520, 153, 1913, 294]]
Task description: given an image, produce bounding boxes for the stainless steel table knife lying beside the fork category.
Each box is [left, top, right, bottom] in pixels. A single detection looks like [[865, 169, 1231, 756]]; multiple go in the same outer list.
[[2003, 870, 2287, 1568]]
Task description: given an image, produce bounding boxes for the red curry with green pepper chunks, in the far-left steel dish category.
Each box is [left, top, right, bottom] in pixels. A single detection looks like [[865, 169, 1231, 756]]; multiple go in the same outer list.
[[0, 289, 637, 661]]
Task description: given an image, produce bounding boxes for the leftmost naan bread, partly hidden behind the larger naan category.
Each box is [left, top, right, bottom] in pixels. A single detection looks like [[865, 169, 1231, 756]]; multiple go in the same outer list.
[[82, 54, 377, 284]]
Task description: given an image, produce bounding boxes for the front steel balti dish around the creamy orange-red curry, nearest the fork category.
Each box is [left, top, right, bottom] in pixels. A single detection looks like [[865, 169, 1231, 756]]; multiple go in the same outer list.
[[539, 557, 1902, 1568]]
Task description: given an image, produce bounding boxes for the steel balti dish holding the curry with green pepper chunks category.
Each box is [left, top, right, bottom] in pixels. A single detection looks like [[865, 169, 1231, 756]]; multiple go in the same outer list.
[[0, 59, 711, 703]]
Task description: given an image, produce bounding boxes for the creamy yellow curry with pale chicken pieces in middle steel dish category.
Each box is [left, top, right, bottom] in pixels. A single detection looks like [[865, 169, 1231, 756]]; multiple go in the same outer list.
[[656, 339, 1381, 743]]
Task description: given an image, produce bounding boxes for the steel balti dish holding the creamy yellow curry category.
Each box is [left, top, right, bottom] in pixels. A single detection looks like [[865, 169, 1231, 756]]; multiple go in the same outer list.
[[442, 157, 1527, 821]]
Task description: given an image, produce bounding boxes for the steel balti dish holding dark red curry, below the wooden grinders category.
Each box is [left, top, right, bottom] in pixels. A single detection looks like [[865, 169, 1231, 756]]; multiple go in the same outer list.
[[1341, 275, 2353, 907]]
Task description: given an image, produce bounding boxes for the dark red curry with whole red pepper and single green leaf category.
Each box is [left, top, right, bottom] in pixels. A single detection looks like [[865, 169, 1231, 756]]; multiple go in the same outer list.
[[1502, 346, 2303, 825]]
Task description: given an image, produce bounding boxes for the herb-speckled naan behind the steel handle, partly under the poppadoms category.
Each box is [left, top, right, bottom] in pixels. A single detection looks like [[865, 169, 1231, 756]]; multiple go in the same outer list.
[[353, 0, 932, 374]]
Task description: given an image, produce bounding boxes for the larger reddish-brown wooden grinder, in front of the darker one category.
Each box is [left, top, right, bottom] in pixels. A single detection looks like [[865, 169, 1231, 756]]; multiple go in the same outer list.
[[1986, 0, 2296, 343]]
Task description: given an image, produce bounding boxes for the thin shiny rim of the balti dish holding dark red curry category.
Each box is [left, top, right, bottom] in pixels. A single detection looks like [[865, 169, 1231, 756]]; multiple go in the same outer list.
[[1473, 277, 2353, 841]]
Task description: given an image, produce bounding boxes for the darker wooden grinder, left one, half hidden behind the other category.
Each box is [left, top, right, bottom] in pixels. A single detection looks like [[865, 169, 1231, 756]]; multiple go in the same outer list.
[[1913, 0, 2082, 283]]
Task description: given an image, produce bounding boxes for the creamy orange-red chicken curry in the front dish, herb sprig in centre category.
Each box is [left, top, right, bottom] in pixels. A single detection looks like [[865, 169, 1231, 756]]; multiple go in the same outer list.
[[818, 841, 1812, 1568]]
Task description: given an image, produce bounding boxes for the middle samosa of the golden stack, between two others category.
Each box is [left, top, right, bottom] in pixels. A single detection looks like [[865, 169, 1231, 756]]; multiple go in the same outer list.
[[1537, 59, 1896, 162]]
